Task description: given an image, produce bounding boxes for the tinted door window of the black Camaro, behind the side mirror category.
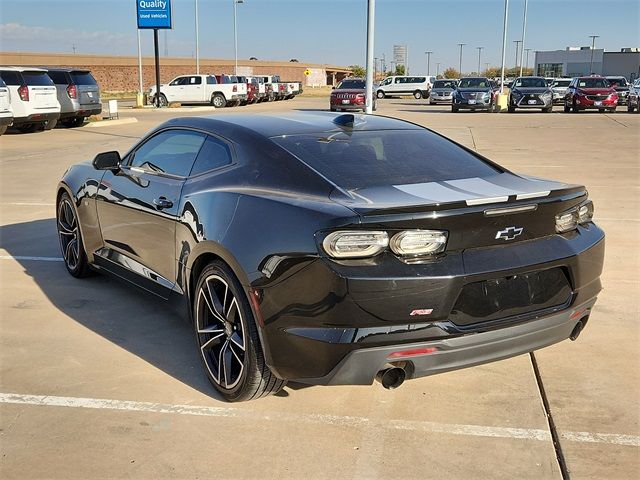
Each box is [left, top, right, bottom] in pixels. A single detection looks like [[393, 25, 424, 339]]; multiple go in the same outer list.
[[130, 130, 206, 177]]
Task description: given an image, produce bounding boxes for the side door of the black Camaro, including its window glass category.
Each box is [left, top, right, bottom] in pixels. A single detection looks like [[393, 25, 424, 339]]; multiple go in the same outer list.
[[94, 129, 206, 298]]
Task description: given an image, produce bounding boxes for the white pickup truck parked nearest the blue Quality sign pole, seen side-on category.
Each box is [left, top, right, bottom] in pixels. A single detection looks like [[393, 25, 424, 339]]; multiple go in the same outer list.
[[148, 75, 247, 108]]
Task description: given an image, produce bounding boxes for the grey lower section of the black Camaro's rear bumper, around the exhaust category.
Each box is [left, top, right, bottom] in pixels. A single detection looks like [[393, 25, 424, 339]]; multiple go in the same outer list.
[[299, 298, 596, 385]]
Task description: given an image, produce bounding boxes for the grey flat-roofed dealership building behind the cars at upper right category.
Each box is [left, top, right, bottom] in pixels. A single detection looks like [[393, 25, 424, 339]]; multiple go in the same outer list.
[[535, 47, 640, 81]]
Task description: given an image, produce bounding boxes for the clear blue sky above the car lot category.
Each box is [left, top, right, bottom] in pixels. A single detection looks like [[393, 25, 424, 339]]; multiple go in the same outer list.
[[0, 0, 640, 73]]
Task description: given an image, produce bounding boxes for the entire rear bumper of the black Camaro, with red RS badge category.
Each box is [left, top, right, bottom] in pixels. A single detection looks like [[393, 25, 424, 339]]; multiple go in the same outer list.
[[253, 224, 604, 384]]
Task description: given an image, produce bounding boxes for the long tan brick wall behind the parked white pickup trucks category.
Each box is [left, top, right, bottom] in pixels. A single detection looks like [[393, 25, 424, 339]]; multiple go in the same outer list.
[[0, 52, 349, 92]]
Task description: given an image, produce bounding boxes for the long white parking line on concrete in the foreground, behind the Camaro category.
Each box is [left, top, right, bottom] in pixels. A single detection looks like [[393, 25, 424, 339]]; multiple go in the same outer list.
[[0, 393, 640, 447]]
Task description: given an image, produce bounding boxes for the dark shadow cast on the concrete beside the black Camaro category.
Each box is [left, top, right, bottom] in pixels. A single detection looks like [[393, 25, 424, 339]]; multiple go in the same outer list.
[[0, 218, 221, 399]]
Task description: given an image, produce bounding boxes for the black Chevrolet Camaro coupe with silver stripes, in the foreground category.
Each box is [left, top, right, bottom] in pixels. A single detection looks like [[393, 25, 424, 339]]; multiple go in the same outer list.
[[57, 112, 604, 401]]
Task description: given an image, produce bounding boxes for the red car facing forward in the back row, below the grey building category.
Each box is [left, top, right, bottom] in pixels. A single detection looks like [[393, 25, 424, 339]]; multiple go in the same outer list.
[[564, 76, 618, 113]]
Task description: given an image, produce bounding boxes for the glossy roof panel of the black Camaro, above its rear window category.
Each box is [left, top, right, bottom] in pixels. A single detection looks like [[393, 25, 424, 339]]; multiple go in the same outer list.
[[165, 112, 423, 139]]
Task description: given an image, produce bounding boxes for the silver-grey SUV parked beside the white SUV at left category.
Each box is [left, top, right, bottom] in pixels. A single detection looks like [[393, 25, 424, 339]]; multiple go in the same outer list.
[[47, 68, 102, 127]]
